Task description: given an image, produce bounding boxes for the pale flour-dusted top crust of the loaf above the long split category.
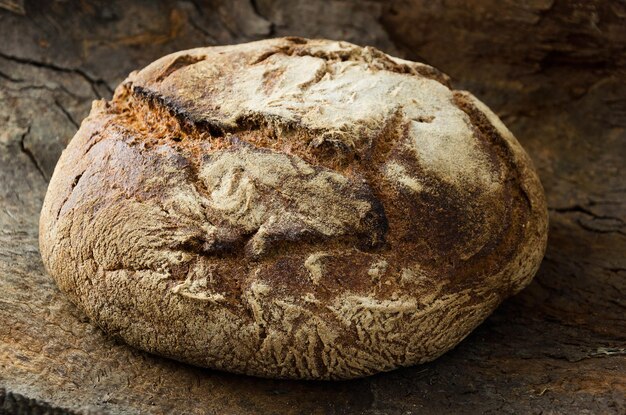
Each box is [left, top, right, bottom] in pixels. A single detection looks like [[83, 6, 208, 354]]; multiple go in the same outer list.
[[128, 39, 498, 187]]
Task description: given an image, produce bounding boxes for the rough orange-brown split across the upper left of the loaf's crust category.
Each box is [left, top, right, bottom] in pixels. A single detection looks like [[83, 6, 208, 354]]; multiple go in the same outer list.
[[111, 83, 358, 170]]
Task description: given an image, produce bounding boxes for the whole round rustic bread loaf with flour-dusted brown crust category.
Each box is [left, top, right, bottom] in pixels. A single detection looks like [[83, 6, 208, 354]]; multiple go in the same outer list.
[[40, 38, 547, 379]]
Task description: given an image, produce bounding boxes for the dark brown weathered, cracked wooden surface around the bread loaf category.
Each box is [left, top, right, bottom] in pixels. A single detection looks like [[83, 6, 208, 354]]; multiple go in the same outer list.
[[0, 0, 626, 414]]
